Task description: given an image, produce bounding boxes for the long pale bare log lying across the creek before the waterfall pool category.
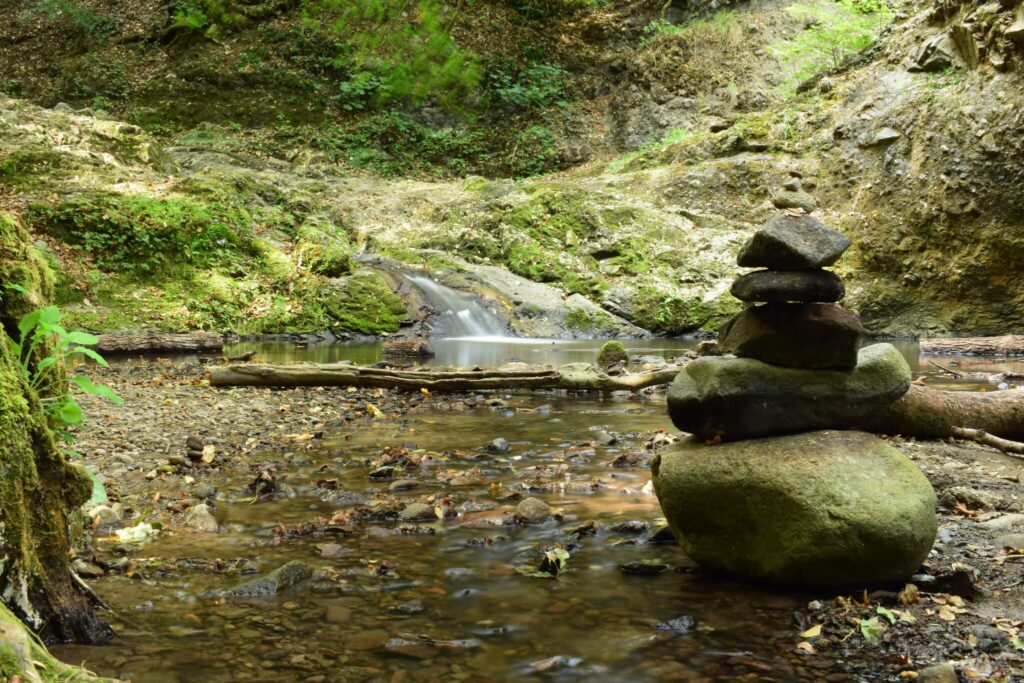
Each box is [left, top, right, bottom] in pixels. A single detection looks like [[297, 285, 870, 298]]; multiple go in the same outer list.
[[207, 362, 682, 391]]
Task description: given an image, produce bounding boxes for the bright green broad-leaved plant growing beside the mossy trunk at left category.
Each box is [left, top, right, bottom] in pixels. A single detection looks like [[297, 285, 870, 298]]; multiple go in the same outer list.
[[11, 306, 124, 445]]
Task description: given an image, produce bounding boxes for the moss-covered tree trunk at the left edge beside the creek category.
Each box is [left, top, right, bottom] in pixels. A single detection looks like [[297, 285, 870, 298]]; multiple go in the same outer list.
[[0, 212, 113, 655]]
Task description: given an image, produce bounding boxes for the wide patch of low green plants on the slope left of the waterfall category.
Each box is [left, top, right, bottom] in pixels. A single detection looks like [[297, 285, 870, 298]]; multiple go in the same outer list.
[[32, 195, 251, 275]]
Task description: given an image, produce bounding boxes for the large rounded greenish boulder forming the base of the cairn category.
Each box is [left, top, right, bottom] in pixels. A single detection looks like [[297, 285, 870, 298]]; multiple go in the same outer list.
[[651, 430, 937, 588]]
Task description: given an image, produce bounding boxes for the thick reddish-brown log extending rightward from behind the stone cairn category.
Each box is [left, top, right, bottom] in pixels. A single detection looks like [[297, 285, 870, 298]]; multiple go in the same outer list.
[[861, 384, 1024, 439]]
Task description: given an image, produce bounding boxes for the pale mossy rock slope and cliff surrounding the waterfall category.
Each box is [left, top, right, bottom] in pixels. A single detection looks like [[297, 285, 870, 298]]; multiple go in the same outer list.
[[0, 0, 1024, 335]]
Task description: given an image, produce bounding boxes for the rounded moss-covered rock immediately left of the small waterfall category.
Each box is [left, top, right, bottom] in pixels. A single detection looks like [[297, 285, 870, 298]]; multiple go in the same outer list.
[[322, 272, 408, 335]]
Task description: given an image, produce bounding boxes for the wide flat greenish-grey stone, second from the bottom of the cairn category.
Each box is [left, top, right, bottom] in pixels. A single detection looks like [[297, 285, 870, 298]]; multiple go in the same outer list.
[[669, 344, 910, 441]]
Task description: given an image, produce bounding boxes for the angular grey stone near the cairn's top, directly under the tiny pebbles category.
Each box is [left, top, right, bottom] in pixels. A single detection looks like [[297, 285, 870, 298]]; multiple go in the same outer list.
[[736, 213, 850, 270]]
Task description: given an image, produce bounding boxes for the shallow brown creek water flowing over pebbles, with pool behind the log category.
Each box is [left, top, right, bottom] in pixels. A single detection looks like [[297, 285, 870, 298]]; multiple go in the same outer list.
[[55, 341, 1024, 683]]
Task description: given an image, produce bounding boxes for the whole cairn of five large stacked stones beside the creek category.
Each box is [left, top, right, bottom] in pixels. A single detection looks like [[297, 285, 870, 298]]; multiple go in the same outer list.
[[652, 212, 937, 586]]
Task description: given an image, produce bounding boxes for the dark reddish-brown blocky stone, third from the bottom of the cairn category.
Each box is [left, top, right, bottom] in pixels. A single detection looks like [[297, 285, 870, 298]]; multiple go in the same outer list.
[[718, 303, 864, 370]]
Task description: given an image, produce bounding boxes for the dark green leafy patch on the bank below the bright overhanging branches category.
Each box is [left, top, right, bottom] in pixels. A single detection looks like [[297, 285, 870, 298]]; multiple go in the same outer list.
[[313, 112, 489, 176]]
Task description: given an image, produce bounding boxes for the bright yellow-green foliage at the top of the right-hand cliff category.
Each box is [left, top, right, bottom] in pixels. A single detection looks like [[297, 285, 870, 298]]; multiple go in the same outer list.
[[774, 0, 893, 95]]
